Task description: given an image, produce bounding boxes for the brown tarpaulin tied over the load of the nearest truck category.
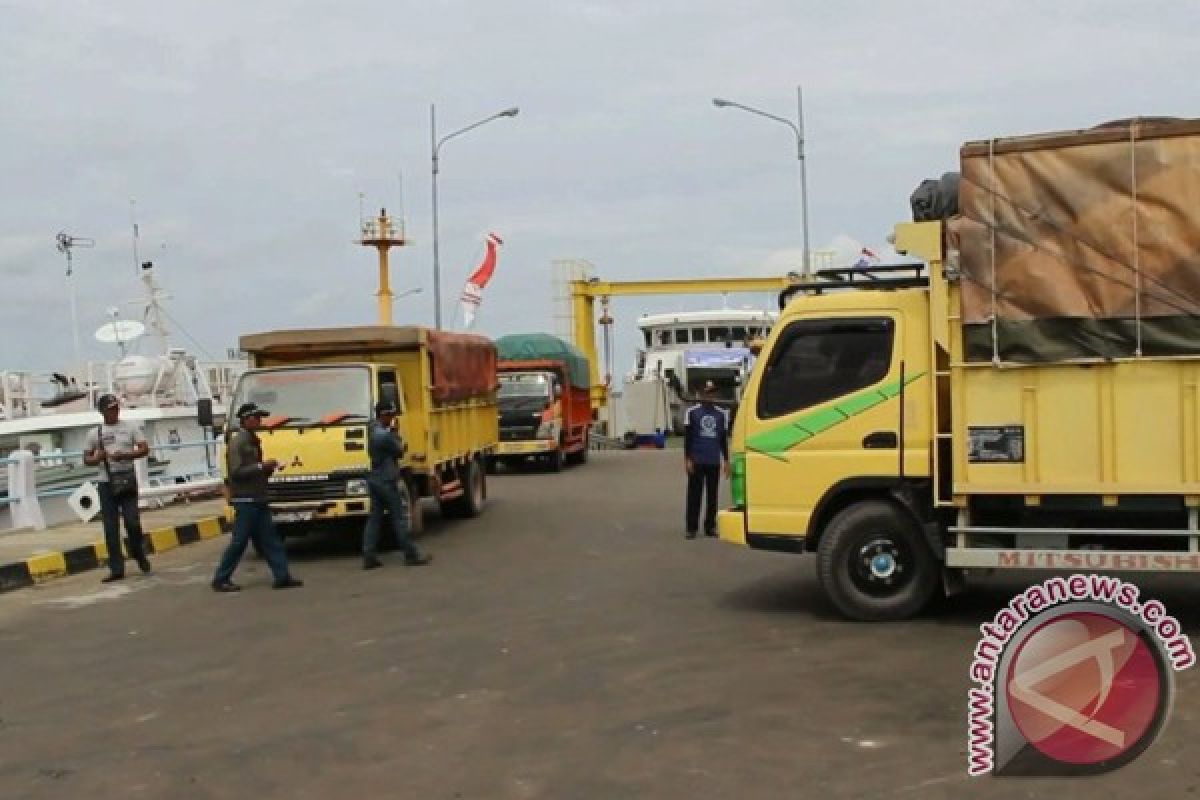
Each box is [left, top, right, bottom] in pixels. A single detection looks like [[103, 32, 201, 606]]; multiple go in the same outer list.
[[947, 120, 1200, 361]]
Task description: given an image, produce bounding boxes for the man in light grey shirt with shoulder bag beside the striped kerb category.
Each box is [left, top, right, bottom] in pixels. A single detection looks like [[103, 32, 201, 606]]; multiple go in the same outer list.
[[83, 395, 150, 583]]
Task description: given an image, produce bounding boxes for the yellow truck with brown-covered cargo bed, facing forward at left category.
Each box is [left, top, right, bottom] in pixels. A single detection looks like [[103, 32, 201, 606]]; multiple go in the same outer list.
[[230, 325, 498, 535]]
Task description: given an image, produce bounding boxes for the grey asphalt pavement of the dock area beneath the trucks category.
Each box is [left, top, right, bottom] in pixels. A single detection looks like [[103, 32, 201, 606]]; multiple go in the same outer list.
[[0, 451, 1200, 800]]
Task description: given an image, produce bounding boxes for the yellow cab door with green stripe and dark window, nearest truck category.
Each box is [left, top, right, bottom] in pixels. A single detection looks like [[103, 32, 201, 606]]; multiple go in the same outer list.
[[742, 312, 904, 536]]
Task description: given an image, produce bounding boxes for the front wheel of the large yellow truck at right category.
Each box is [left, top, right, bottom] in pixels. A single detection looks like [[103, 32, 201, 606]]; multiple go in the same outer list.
[[817, 500, 938, 622]]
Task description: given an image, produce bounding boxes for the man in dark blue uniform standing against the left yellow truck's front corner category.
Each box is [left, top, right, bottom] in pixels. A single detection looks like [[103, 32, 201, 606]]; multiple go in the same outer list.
[[362, 401, 431, 570]]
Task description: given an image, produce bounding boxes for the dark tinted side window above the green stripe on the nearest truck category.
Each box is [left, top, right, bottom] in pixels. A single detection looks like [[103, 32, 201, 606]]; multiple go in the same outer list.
[[758, 318, 895, 420]]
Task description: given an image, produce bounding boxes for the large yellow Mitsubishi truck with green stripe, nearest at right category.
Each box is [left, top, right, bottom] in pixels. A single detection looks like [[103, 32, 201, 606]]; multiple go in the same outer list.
[[719, 120, 1200, 620]]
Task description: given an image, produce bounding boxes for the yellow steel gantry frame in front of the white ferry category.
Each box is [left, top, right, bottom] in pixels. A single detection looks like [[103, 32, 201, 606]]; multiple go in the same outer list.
[[570, 275, 799, 411]]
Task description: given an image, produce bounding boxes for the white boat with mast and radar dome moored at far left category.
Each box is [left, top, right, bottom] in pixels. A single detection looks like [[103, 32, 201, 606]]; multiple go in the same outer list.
[[0, 261, 245, 530]]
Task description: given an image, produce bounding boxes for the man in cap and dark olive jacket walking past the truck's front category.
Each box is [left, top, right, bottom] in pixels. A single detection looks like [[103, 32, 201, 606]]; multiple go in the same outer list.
[[212, 403, 304, 591]]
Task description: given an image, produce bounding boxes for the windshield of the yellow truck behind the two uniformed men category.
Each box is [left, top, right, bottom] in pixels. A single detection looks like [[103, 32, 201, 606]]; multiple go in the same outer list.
[[229, 367, 371, 425]]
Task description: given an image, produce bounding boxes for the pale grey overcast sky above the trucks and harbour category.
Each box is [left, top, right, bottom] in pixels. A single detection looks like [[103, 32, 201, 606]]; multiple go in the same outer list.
[[0, 0, 1200, 373]]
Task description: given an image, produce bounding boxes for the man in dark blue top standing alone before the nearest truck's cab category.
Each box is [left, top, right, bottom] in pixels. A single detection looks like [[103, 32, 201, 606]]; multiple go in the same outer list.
[[683, 380, 730, 539]]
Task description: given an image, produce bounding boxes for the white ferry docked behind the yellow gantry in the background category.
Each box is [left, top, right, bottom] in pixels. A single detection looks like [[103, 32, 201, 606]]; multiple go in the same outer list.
[[611, 308, 779, 439]]
